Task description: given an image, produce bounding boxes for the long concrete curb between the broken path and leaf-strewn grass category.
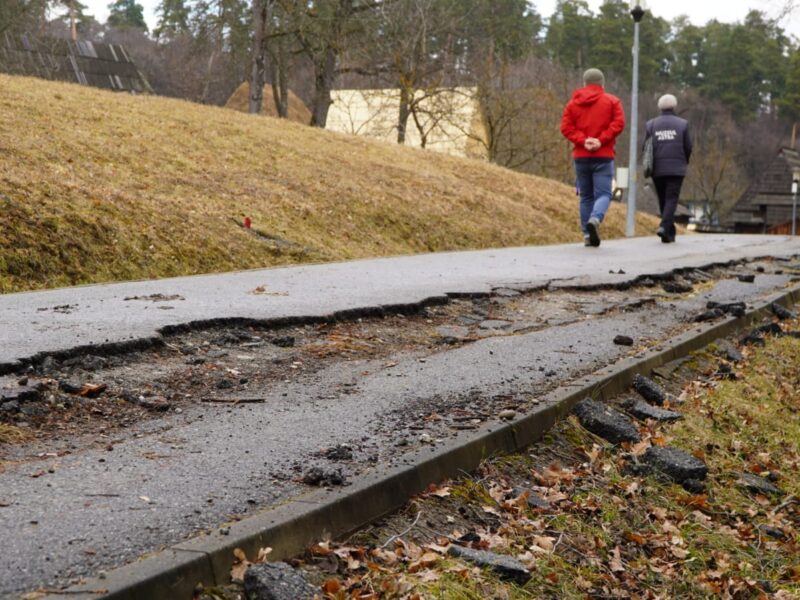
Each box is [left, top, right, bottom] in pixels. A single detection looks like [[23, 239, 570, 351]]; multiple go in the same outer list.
[[45, 285, 800, 600]]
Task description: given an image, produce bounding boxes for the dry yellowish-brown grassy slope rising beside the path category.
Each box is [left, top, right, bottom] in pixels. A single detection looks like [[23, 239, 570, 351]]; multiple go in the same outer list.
[[0, 75, 655, 292]]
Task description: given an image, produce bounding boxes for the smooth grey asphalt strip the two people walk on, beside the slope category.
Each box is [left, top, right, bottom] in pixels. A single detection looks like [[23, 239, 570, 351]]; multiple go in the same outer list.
[[0, 235, 800, 367]]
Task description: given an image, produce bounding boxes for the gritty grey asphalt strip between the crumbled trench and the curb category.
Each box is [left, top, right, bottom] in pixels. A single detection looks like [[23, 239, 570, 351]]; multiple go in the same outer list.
[[0, 264, 791, 597]]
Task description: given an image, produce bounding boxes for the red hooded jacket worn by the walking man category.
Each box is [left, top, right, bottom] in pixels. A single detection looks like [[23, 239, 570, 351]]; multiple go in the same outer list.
[[561, 84, 625, 158]]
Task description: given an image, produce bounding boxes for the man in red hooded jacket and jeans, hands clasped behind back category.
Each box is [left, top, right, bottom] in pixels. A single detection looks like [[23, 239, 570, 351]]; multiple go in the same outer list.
[[561, 69, 625, 247]]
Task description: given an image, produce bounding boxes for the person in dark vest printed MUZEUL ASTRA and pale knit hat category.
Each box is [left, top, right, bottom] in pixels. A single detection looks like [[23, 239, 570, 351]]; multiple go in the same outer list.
[[645, 94, 692, 244]]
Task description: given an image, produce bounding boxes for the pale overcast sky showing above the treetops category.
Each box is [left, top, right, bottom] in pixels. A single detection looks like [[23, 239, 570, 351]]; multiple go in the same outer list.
[[83, 0, 800, 37]]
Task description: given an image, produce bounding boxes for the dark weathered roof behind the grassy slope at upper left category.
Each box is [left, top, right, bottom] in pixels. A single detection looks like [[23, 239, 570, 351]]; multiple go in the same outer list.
[[0, 33, 151, 93]]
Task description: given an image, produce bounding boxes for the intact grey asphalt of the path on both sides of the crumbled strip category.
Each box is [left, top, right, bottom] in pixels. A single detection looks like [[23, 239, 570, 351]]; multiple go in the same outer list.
[[0, 236, 798, 597]]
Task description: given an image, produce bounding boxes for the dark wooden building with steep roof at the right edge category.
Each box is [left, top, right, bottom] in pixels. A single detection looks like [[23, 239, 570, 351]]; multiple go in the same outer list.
[[725, 148, 800, 233]]
